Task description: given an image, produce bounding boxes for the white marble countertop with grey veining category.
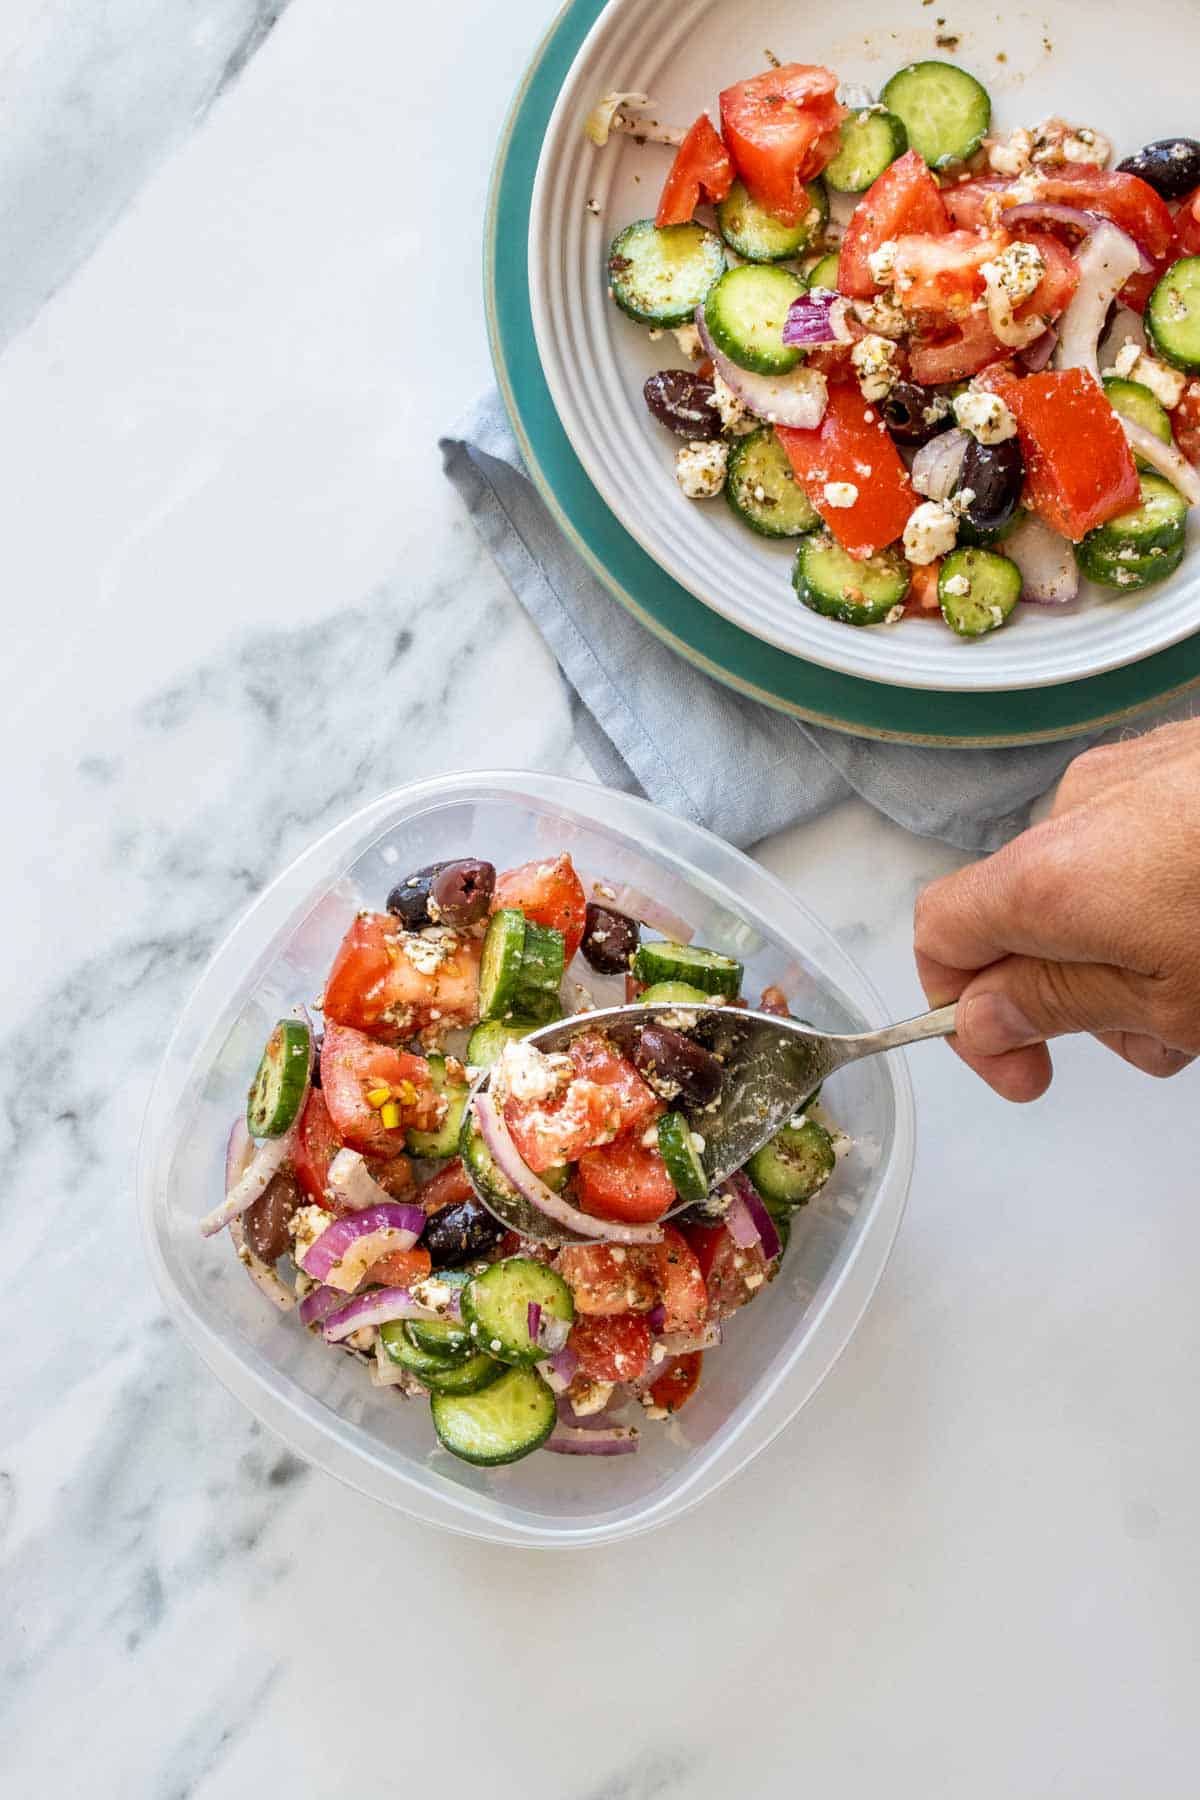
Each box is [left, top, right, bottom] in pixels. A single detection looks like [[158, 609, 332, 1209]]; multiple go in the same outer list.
[[0, 0, 1200, 1800]]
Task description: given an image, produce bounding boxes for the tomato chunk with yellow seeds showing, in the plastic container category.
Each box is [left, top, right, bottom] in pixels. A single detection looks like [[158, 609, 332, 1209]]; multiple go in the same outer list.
[[320, 1022, 446, 1157]]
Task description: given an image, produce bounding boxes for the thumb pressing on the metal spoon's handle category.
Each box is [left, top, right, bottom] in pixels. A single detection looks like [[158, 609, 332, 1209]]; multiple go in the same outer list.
[[955, 956, 1153, 1057]]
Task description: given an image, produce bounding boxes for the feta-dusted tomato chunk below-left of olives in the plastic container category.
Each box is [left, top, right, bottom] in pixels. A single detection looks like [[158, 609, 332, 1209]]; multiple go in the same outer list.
[[324, 913, 479, 1044]]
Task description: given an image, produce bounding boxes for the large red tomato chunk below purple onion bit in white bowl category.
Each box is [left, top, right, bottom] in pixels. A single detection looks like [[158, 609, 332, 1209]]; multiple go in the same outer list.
[[775, 387, 916, 556]]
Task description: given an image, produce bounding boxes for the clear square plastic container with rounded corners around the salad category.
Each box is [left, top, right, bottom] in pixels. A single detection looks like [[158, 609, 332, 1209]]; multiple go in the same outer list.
[[139, 774, 914, 1548]]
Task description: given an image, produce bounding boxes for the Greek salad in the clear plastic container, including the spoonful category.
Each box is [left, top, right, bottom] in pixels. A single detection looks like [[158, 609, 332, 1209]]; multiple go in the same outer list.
[[200, 853, 847, 1465]]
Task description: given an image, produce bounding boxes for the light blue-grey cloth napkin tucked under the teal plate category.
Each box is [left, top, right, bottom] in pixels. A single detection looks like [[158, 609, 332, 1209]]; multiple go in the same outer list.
[[441, 392, 1189, 851]]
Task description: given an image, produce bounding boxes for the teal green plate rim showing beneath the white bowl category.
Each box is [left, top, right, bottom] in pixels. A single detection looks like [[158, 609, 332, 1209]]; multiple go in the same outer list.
[[484, 0, 1200, 749]]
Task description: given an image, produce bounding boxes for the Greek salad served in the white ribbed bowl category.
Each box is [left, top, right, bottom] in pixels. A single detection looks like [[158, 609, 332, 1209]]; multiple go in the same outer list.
[[587, 61, 1200, 639]]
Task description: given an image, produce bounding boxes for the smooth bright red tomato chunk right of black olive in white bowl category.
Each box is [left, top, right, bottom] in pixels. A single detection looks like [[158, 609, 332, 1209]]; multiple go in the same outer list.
[[988, 369, 1141, 544]]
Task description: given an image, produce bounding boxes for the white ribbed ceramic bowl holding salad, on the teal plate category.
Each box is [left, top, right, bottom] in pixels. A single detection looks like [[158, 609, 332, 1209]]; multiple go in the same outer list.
[[529, 0, 1200, 689]]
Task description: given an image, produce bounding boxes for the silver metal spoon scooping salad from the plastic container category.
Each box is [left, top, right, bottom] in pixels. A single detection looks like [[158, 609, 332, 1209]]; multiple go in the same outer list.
[[464, 1003, 955, 1246]]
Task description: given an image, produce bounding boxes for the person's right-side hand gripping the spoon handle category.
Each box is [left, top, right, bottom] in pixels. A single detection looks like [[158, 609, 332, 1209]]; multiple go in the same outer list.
[[914, 720, 1200, 1100]]
